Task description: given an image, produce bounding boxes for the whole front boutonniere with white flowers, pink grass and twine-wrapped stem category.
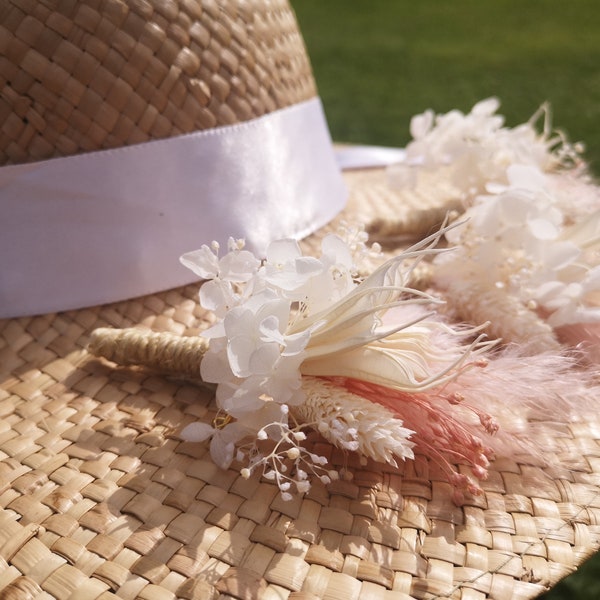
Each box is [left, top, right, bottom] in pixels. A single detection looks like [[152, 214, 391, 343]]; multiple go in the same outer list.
[[91, 227, 600, 500]]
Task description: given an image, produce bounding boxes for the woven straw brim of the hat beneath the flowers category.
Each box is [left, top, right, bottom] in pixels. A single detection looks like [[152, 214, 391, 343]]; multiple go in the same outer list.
[[0, 173, 600, 600]]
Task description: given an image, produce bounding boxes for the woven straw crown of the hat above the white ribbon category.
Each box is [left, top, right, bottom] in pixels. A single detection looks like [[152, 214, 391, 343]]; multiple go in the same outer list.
[[0, 0, 316, 164]]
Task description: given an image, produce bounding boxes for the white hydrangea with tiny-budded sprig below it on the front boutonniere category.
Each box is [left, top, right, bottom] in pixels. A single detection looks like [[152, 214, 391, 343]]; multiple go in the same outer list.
[[181, 226, 411, 497]]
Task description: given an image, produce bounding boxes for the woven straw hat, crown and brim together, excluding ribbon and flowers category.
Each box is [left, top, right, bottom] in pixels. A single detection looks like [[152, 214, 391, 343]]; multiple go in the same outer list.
[[0, 0, 600, 600]]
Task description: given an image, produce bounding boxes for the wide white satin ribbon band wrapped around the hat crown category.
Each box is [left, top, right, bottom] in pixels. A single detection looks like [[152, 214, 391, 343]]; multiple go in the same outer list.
[[0, 98, 346, 317]]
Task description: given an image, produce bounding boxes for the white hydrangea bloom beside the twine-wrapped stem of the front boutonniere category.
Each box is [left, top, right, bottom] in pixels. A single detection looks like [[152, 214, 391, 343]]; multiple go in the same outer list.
[[181, 235, 366, 422]]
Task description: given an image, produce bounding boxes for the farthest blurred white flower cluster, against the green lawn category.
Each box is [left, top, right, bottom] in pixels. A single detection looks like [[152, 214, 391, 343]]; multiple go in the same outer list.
[[389, 98, 581, 205]]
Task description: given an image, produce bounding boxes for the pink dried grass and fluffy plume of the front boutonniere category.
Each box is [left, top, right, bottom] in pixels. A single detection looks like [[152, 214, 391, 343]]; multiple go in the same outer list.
[[329, 347, 600, 503]]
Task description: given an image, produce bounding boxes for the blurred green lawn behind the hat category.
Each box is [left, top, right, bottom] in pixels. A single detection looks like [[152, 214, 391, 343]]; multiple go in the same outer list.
[[292, 0, 600, 600]]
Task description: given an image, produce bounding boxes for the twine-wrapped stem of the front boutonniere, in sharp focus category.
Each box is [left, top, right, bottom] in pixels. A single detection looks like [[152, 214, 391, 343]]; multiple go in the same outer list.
[[88, 327, 208, 379]]
